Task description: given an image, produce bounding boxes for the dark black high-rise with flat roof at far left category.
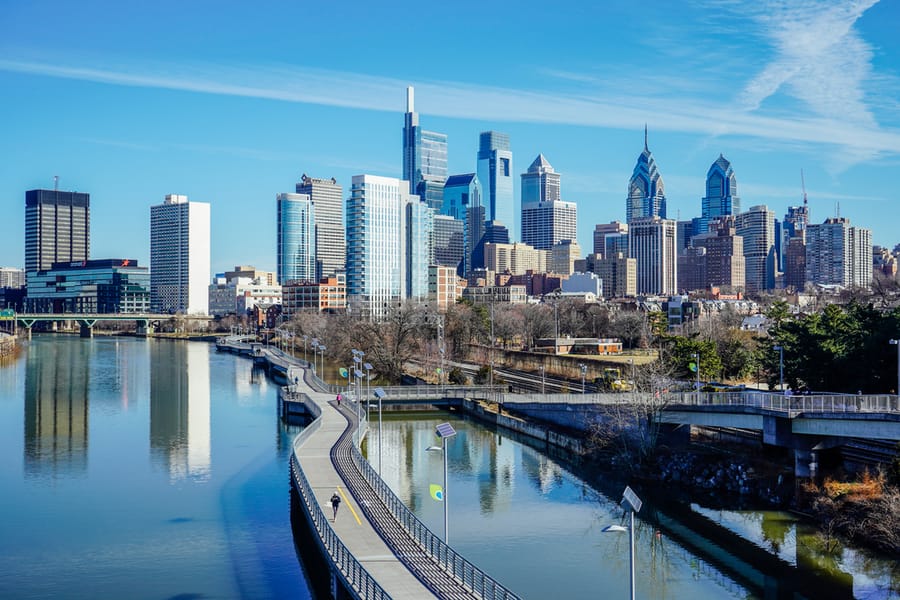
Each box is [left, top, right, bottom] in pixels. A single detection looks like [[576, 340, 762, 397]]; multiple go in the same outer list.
[[25, 190, 91, 272]]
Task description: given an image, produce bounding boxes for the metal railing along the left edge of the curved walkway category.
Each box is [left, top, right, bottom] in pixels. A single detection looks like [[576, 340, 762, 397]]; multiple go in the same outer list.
[[291, 394, 390, 600]]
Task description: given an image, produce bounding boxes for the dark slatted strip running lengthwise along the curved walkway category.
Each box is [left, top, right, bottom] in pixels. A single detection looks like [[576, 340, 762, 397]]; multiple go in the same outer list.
[[330, 402, 481, 600]]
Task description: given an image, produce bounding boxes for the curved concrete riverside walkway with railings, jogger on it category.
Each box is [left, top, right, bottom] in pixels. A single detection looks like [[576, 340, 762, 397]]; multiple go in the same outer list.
[[217, 342, 517, 600]]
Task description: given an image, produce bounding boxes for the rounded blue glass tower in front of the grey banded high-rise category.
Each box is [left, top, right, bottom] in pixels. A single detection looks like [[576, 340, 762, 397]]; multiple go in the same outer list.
[[276, 194, 318, 285]]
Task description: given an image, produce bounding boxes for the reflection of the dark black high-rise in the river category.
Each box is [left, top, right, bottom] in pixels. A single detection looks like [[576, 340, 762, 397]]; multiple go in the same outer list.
[[25, 344, 94, 478]]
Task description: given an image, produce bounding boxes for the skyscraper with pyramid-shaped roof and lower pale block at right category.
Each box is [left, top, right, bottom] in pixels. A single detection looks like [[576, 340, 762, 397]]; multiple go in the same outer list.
[[522, 154, 578, 250]]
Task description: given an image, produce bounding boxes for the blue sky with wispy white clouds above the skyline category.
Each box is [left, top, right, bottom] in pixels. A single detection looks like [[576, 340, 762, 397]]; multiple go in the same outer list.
[[0, 0, 900, 272]]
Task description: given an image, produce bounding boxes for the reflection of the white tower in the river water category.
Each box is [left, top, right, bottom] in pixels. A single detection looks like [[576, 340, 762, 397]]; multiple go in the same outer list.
[[150, 340, 210, 480]]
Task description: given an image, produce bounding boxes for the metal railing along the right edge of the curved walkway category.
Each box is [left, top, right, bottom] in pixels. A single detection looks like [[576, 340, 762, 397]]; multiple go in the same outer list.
[[351, 436, 518, 600]]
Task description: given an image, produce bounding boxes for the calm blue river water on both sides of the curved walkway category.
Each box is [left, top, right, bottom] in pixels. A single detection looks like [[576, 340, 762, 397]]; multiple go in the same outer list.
[[0, 336, 900, 599]]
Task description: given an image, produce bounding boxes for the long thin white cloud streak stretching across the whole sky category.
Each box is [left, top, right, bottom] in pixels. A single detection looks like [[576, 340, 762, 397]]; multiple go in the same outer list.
[[0, 46, 900, 164]]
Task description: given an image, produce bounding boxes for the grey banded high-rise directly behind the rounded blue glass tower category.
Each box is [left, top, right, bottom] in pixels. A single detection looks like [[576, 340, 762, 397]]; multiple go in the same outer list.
[[295, 173, 347, 280]]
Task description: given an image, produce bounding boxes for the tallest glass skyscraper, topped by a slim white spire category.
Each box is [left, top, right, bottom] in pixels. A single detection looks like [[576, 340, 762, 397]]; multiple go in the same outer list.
[[403, 86, 447, 212]]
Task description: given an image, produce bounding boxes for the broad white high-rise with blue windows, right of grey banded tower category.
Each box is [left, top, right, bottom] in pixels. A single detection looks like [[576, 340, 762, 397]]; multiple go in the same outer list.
[[347, 175, 430, 320]]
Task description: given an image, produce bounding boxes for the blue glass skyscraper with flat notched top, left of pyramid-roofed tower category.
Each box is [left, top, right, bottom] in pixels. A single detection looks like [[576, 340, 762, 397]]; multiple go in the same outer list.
[[478, 131, 519, 240]]
